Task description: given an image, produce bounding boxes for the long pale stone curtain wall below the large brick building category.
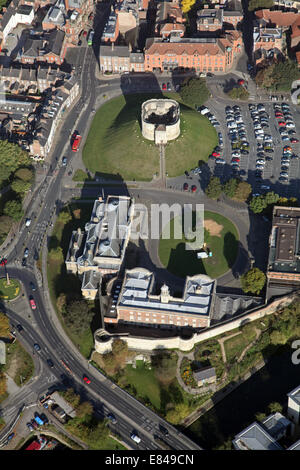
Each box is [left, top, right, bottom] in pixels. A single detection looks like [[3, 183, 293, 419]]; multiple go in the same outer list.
[[94, 293, 297, 354]]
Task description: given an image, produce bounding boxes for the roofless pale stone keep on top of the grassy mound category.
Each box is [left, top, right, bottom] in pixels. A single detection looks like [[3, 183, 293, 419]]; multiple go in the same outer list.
[[142, 99, 180, 145]]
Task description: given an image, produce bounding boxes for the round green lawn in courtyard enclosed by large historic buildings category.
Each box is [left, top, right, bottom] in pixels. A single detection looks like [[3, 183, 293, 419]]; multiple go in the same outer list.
[[159, 211, 239, 279]]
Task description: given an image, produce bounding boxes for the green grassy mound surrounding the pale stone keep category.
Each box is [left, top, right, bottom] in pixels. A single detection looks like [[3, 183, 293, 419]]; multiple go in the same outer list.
[[83, 93, 217, 181]]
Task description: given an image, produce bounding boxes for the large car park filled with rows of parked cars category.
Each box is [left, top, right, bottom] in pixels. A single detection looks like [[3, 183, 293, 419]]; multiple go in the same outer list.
[[206, 102, 300, 197]]
